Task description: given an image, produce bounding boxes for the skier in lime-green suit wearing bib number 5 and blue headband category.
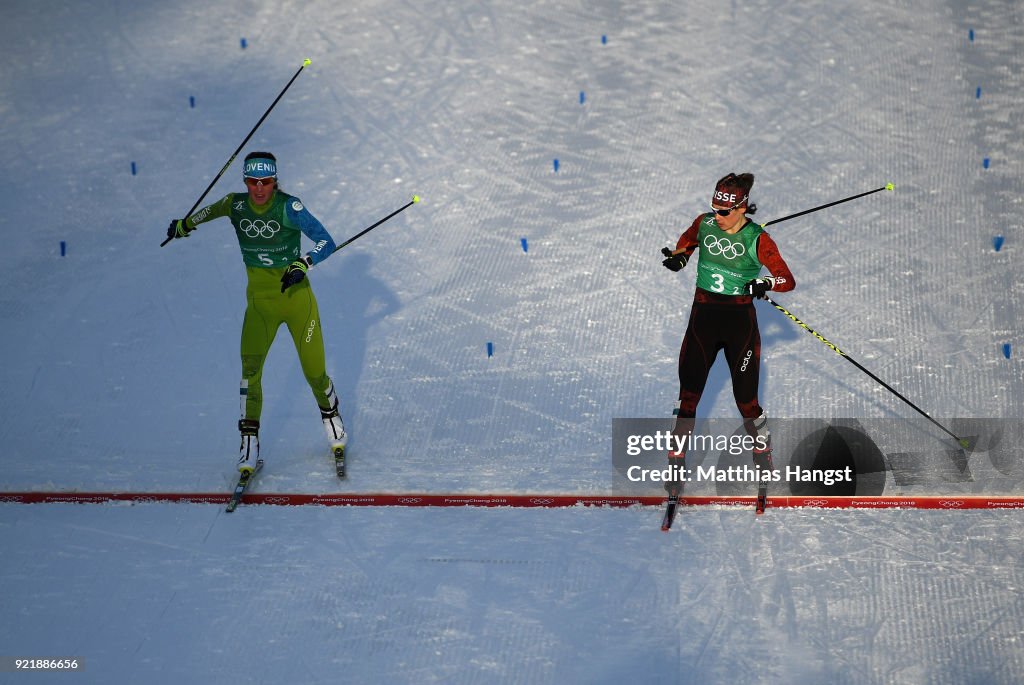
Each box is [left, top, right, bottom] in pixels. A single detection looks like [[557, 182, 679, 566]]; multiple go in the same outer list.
[[167, 153, 348, 473]]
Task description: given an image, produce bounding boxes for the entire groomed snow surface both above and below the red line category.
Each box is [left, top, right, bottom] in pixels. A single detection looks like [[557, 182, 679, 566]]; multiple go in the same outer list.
[[0, 0, 1024, 683]]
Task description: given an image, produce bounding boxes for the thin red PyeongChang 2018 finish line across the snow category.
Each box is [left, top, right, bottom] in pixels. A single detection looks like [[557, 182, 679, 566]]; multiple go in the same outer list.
[[0, 493, 1024, 510]]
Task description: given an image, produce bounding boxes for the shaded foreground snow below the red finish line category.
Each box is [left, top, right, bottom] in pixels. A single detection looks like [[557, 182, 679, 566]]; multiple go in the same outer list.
[[6, 504, 1024, 685]]
